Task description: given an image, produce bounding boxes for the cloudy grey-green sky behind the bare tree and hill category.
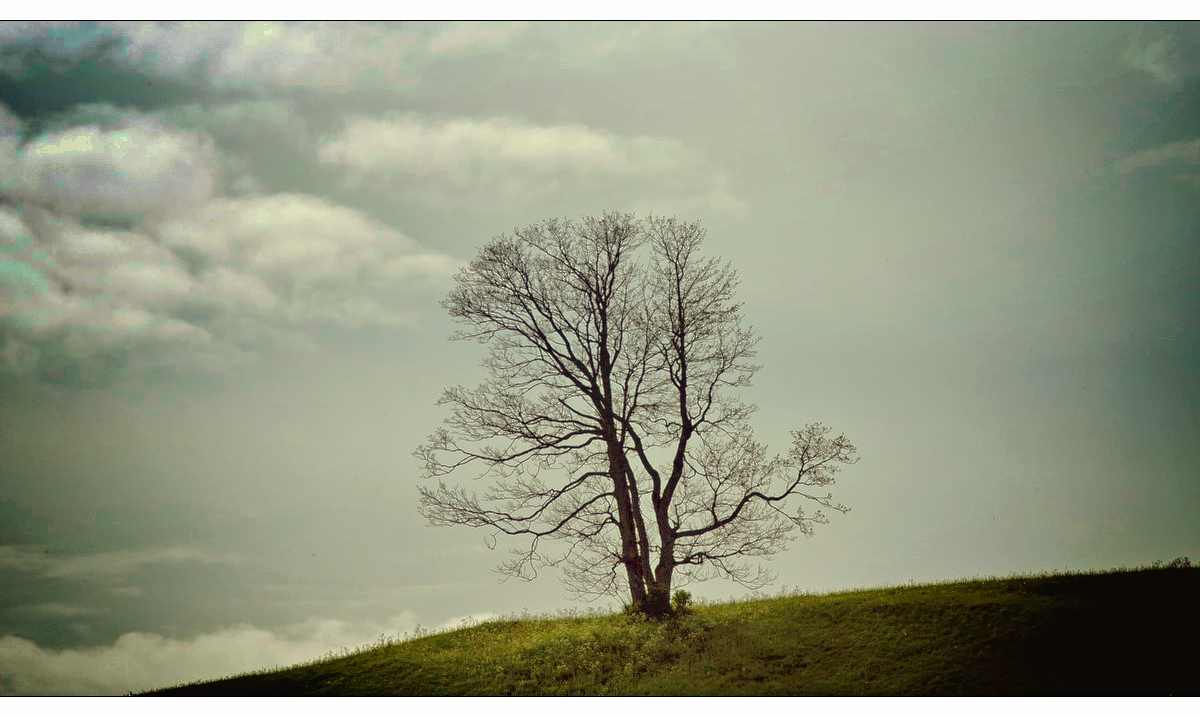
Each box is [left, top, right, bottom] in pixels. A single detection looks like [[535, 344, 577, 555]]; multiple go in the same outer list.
[[0, 22, 1200, 694]]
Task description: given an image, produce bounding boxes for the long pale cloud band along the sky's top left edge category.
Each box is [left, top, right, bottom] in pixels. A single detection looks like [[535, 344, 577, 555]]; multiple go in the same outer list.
[[0, 20, 728, 99]]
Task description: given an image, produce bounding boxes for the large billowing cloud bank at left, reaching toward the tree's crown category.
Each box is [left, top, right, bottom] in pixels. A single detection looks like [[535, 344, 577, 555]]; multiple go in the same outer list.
[[0, 101, 457, 385]]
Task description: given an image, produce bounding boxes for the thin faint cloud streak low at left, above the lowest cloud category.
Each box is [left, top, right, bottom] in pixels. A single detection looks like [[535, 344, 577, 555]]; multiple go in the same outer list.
[[0, 546, 241, 585]]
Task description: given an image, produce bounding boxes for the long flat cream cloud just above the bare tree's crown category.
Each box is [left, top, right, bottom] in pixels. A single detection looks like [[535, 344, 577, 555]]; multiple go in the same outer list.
[[318, 114, 737, 209]]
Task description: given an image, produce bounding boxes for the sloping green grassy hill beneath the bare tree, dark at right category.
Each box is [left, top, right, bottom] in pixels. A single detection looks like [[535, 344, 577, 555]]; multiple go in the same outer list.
[[146, 567, 1200, 695]]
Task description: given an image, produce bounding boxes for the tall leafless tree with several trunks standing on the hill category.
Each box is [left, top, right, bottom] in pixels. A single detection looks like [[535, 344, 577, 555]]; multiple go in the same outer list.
[[416, 213, 857, 616]]
